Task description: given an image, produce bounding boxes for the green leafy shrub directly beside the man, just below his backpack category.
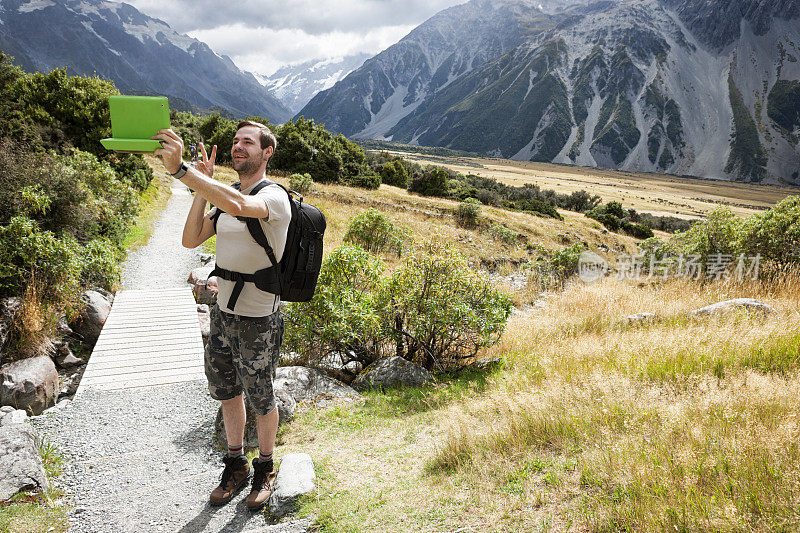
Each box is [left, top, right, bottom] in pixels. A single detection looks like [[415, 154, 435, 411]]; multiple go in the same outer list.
[[285, 245, 384, 374]]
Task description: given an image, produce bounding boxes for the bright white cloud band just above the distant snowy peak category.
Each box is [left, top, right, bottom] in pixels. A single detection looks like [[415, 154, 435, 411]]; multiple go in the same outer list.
[[189, 23, 414, 74]]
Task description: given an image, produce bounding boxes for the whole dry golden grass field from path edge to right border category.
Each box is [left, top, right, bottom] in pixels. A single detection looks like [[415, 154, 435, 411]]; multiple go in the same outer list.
[[277, 268, 800, 532]]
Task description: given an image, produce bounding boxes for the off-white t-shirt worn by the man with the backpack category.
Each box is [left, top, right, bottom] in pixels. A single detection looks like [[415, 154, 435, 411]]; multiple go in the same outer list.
[[212, 180, 292, 316]]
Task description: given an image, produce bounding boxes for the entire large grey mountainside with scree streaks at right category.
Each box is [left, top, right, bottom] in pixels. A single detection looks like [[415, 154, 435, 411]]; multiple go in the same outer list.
[[300, 0, 800, 182]]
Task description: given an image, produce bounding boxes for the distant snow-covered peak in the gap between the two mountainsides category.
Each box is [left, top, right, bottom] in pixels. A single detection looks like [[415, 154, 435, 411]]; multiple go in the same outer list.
[[256, 54, 372, 113]]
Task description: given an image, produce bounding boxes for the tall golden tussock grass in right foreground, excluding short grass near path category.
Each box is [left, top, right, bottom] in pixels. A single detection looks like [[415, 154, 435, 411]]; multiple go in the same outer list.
[[428, 277, 800, 531]]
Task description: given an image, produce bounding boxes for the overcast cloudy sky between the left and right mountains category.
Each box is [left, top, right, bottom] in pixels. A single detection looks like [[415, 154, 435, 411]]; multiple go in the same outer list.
[[126, 0, 466, 74]]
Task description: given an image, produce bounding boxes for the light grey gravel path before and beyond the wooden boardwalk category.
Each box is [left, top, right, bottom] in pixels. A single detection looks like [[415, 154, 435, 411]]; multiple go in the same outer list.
[[31, 181, 310, 533]]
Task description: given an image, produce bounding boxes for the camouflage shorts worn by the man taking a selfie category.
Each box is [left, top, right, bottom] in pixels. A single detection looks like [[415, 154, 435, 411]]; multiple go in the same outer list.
[[205, 305, 283, 415]]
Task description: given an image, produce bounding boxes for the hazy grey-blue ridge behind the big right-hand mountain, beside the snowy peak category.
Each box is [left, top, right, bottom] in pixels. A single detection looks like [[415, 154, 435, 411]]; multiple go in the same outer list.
[[299, 0, 551, 138]]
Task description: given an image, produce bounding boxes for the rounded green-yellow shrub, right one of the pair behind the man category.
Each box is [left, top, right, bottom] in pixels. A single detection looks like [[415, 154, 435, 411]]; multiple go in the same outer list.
[[383, 244, 512, 369]]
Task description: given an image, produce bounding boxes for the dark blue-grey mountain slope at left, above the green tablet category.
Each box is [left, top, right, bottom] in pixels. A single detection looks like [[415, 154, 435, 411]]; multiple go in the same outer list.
[[0, 0, 291, 122]]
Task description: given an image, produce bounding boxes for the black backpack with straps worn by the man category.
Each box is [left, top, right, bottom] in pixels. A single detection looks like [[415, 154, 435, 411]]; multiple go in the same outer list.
[[209, 181, 326, 310]]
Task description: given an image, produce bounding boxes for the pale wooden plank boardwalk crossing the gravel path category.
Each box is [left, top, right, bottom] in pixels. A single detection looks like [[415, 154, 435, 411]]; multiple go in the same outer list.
[[76, 287, 205, 394]]
